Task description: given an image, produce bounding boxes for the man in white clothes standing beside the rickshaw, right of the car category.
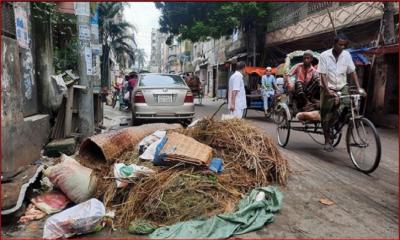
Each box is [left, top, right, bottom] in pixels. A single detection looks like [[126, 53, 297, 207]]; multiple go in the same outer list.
[[228, 61, 247, 118]]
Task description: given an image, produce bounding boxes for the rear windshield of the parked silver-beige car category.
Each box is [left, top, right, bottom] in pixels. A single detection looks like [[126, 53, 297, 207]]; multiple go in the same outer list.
[[139, 75, 186, 87]]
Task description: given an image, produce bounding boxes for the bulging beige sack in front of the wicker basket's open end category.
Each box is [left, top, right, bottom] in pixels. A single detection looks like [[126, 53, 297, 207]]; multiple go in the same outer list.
[[44, 154, 96, 203]]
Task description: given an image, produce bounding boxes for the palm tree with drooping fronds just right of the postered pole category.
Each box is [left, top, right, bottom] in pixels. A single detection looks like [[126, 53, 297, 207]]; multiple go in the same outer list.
[[99, 2, 136, 87]]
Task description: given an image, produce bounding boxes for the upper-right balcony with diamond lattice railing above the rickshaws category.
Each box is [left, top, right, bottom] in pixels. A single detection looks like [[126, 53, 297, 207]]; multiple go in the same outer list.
[[266, 2, 388, 46]]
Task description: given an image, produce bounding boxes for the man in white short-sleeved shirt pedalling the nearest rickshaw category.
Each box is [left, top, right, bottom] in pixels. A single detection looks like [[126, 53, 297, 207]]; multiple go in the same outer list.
[[317, 34, 365, 152]]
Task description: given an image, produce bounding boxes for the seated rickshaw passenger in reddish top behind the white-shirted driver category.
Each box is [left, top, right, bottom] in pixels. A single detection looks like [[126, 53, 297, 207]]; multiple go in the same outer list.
[[285, 50, 320, 112]]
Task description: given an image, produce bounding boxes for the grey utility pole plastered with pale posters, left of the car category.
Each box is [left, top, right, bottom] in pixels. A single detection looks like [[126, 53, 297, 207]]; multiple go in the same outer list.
[[75, 2, 94, 139]]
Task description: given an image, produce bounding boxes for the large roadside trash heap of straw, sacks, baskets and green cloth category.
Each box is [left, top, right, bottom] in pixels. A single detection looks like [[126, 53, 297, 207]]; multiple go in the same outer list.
[[6, 119, 289, 238]]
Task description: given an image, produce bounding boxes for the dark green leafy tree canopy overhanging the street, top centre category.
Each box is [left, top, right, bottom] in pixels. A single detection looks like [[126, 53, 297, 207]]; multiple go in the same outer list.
[[155, 2, 271, 64]]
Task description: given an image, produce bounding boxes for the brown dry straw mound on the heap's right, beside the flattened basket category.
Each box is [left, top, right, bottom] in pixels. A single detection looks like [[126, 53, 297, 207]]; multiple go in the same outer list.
[[181, 119, 288, 189]]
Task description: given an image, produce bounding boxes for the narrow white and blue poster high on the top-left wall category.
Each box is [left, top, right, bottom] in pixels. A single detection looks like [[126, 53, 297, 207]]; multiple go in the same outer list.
[[14, 6, 29, 48]]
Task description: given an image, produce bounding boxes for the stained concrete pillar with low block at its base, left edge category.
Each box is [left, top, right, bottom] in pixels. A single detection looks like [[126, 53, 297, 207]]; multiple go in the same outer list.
[[1, 36, 49, 172]]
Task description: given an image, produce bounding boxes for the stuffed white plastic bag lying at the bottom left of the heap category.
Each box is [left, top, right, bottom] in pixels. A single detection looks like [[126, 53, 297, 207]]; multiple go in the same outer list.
[[43, 198, 106, 239]]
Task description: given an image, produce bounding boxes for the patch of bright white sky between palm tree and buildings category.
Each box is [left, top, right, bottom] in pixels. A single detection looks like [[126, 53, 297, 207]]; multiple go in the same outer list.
[[124, 2, 161, 62]]
